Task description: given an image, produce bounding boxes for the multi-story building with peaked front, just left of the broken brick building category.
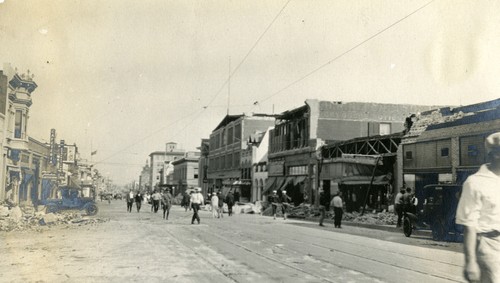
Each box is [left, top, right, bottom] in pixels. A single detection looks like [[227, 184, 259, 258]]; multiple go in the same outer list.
[[207, 114, 274, 199]]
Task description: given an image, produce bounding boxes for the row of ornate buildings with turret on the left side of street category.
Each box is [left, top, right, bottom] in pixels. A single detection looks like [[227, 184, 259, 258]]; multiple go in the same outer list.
[[0, 64, 103, 206]]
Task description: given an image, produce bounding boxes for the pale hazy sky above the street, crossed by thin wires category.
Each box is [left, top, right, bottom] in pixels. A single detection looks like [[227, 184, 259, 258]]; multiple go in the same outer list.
[[0, 0, 500, 185]]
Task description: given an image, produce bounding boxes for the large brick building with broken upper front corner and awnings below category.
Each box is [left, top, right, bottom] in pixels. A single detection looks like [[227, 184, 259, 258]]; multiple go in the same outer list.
[[264, 99, 431, 204]]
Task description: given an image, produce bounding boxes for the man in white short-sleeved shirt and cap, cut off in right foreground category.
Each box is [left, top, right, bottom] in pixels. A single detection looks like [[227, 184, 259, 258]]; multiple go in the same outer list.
[[456, 132, 500, 282]]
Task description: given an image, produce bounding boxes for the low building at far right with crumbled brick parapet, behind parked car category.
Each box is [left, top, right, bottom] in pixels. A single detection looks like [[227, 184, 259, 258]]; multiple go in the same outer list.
[[401, 99, 500, 211]]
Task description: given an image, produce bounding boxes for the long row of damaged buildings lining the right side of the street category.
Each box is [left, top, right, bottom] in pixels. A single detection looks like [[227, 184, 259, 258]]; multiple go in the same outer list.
[[140, 99, 500, 213]]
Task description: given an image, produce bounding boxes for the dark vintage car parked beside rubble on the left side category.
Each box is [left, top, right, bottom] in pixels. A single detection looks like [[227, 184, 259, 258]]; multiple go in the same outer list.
[[41, 186, 99, 215]]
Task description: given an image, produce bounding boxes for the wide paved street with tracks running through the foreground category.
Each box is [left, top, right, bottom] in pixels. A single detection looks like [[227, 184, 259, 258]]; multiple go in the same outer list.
[[0, 201, 463, 282]]
